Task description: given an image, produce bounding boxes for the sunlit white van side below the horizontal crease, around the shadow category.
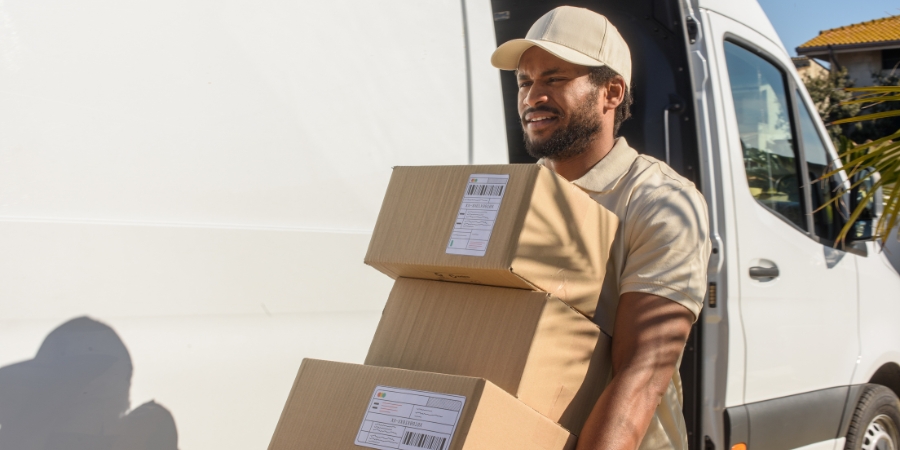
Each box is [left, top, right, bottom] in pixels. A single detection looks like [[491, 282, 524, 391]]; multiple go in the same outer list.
[[0, 215, 391, 449]]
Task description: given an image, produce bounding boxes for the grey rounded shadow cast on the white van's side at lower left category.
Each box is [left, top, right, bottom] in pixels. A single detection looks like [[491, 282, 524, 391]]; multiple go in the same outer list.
[[0, 317, 178, 450]]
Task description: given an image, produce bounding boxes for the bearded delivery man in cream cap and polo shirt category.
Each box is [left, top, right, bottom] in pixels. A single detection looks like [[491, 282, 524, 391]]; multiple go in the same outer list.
[[491, 7, 711, 450]]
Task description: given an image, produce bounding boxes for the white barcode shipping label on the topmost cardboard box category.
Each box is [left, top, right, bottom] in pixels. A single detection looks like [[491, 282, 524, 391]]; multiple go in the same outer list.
[[447, 173, 509, 256]]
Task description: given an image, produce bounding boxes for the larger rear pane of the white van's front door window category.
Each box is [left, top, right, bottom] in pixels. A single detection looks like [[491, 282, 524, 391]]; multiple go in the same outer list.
[[725, 41, 807, 232]]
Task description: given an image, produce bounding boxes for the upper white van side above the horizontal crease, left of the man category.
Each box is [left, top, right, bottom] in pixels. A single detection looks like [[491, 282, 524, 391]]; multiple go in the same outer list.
[[0, 0, 478, 231]]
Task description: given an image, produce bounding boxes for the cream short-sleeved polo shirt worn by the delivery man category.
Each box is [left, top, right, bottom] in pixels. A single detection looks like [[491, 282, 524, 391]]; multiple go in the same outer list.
[[540, 137, 712, 450]]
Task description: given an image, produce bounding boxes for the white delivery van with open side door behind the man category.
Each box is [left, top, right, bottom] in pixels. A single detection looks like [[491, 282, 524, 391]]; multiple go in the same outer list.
[[0, 0, 900, 450]]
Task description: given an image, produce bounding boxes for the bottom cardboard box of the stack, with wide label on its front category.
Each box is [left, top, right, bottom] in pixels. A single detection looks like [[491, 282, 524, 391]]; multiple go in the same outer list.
[[269, 359, 575, 450]]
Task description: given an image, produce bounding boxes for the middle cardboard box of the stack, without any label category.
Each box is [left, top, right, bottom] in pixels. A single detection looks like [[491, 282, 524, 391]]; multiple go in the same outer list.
[[366, 278, 612, 435]]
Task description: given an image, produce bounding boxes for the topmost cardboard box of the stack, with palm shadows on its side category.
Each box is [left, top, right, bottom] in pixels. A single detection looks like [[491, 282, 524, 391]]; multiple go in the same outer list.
[[365, 164, 618, 317]]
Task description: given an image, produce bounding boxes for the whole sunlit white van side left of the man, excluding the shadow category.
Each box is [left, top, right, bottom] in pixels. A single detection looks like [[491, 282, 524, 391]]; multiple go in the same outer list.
[[0, 0, 508, 449]]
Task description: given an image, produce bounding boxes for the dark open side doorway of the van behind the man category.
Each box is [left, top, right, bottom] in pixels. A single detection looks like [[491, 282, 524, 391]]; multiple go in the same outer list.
[[491, 0, 704, 450]]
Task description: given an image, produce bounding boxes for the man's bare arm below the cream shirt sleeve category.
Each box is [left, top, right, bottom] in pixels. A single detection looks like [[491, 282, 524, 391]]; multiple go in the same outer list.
[[577, 292, 694, 450]]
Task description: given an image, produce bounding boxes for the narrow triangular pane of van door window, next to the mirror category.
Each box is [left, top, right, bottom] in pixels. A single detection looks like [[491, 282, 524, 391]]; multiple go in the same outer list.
[[797, 92, 843, 242]]
